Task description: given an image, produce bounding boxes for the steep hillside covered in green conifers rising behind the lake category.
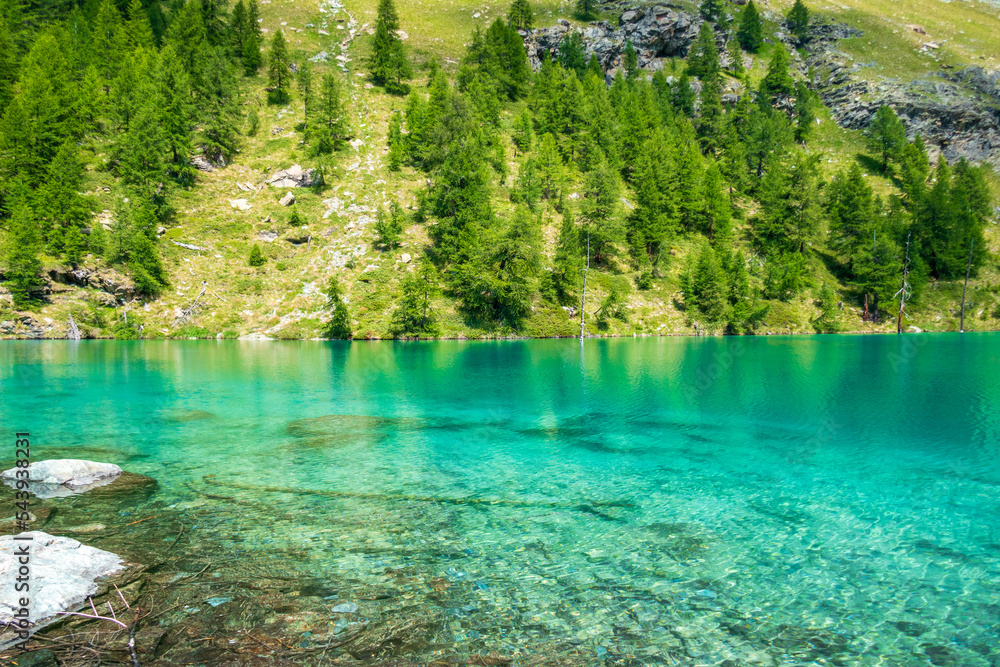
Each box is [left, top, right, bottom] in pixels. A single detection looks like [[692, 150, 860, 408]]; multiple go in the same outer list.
[[0, 0, 1000, 338]]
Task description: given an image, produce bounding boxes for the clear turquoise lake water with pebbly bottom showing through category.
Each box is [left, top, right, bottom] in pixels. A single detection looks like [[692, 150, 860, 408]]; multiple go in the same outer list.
[[0, 334, 1000, 666]]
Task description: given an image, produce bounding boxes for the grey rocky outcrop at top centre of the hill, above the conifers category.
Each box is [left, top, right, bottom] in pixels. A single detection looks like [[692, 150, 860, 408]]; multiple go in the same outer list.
[[521, 5, 701, 70]]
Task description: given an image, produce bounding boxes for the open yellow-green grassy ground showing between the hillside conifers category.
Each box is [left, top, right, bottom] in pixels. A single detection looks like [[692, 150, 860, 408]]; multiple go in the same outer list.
[[4, 0, 1000, 338]]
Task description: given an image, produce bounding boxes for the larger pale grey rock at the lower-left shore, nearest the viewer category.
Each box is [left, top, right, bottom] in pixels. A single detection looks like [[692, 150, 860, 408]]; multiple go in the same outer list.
[[0, 530, 125, 649]]
